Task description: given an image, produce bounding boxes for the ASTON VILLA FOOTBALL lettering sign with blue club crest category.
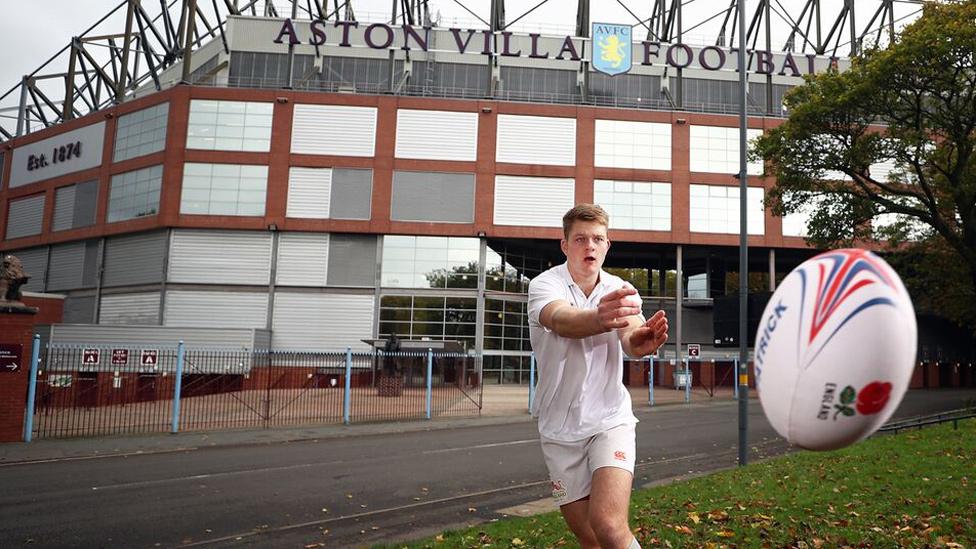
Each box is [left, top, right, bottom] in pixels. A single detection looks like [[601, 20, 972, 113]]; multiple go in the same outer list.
[[273, 19, 838, 77]]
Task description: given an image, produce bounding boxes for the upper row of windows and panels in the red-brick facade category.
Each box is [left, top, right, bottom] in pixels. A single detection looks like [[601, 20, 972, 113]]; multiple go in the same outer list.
[[5, 99, 762, 195]]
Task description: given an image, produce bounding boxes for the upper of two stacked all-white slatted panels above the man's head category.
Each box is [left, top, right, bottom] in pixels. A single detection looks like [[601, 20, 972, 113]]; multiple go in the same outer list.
[[495, 114, 576, 165]]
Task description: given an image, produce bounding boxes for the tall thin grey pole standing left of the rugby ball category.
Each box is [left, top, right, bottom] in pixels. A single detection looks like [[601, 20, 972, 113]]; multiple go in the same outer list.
[[735, 0, 749, 467]]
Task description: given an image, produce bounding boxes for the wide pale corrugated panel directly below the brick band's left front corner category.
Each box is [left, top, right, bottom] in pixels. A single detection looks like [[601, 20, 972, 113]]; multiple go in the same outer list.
[[167, 231, 271, 284]]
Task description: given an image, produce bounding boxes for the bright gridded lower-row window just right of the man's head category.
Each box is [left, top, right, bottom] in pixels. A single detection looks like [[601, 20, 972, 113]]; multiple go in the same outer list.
[[593, 179, 671, 231]]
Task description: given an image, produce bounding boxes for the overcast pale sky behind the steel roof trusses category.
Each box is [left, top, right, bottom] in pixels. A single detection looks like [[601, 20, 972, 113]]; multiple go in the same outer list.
[[0, 0, 917, 101]]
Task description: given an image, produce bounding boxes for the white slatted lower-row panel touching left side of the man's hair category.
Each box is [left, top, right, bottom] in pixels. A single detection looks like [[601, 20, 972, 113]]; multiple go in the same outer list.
[[495, 175, 576, 227]]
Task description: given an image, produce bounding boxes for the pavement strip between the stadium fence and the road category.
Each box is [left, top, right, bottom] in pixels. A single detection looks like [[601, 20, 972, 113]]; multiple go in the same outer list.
[[0, 385, 732, 466]]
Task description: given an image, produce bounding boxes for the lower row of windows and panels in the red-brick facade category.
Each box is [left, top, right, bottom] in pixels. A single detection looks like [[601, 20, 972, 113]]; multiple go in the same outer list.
[[5, 163, 824, 239]]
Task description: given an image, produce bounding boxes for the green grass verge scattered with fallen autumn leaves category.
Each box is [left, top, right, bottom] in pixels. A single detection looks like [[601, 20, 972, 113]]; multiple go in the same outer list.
[[381, 419, 976, 549]]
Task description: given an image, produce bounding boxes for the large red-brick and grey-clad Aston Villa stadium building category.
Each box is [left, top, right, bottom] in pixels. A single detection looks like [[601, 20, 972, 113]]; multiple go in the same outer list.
[[0, 0, 972, 384]]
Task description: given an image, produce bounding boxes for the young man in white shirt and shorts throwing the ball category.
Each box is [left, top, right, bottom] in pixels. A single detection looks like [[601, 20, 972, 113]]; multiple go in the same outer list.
[[529, 204, 668, 549]]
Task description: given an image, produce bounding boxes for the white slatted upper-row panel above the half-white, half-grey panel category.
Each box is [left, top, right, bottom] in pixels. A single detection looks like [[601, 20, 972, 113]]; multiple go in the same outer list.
[[291, 105, 376, 156]]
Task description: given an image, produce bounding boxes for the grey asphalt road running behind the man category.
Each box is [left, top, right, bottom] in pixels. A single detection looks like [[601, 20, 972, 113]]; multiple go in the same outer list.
[[0, 390, 976, 548]]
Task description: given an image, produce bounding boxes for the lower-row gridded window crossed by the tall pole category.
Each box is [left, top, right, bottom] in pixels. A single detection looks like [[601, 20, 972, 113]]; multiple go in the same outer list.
[[689, 185, 766, 234]]
